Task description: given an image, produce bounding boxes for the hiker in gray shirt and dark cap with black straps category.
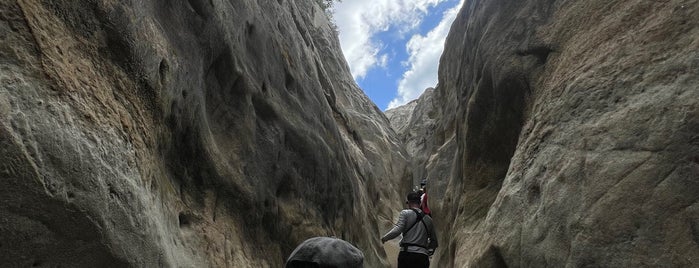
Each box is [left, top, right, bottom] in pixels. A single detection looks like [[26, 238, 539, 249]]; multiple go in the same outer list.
[[381, 192, 438, 268]]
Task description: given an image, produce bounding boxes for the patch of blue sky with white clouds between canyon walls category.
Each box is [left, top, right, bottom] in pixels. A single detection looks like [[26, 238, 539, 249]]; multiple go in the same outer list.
[[333, 0, 464, 111]]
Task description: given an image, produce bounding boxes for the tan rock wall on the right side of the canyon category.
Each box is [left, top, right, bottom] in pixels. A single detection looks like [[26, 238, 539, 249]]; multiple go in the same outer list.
[[412, 0, 699, 267]]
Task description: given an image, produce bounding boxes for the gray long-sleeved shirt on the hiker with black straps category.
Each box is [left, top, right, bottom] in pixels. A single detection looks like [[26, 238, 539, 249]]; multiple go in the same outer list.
[[382, 209, 438, 255]]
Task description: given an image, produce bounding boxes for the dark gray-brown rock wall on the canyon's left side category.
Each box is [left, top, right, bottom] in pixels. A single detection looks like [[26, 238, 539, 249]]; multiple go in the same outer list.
[[0, 0, 408, 267]]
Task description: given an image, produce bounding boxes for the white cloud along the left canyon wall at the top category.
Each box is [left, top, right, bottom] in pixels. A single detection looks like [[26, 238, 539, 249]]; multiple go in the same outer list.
[[334, 0, 447, 79]]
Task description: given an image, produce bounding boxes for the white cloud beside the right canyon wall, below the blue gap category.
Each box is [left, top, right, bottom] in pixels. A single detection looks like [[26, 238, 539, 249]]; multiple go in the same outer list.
[[388, 0, 464, 109]]
